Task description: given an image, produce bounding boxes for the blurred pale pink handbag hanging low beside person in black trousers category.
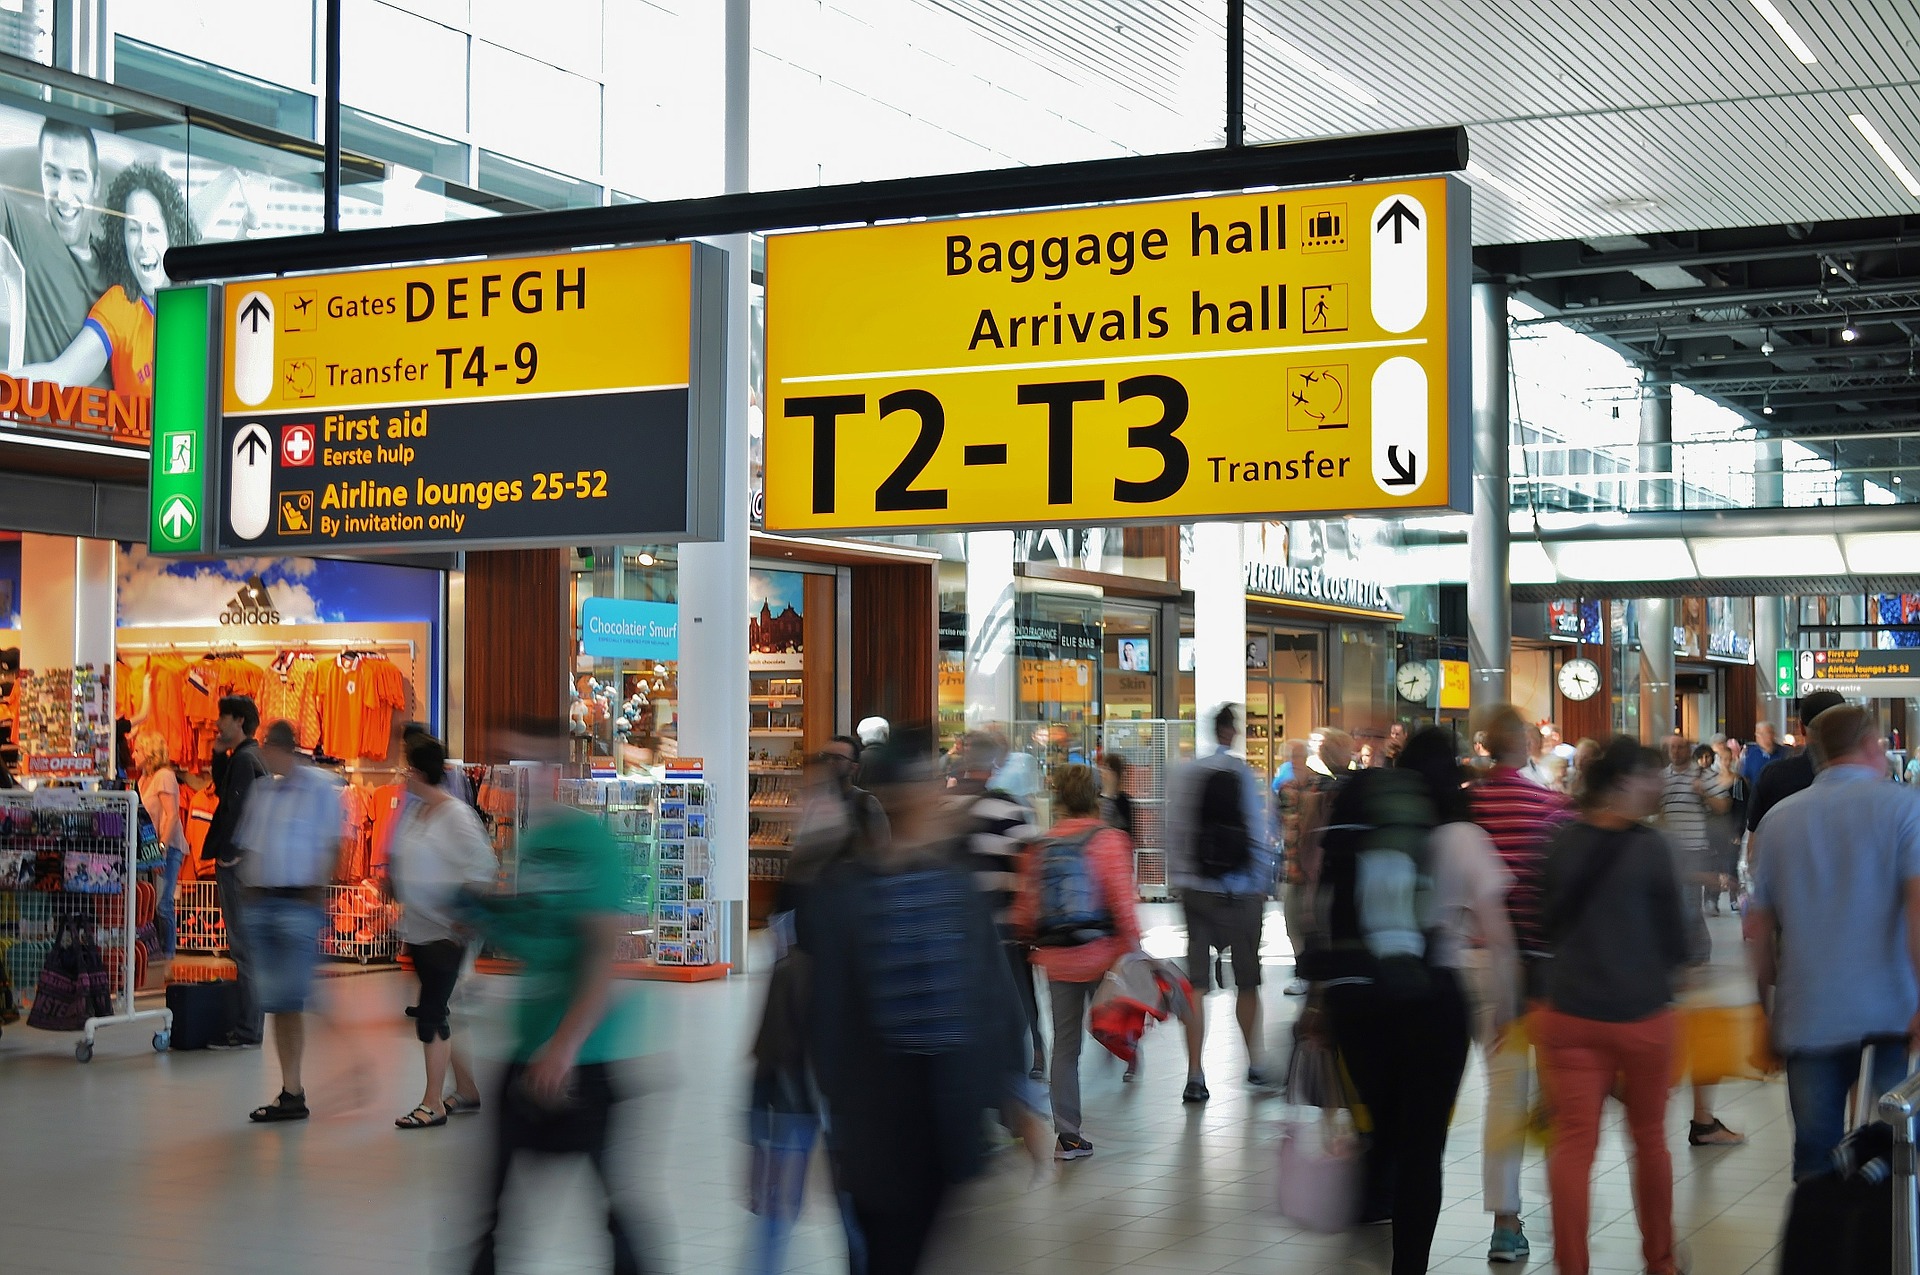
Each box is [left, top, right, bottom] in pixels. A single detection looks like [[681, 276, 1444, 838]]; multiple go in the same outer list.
[[1279, 1037, 1365, 1233]]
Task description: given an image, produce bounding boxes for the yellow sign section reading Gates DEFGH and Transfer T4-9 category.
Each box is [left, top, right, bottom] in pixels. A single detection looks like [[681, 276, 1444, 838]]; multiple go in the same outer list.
[[223, 244, 693, 415]]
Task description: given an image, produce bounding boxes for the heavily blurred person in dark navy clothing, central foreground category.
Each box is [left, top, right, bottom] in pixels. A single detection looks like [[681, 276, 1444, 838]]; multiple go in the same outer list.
[[795, 741, 1023, 1275]]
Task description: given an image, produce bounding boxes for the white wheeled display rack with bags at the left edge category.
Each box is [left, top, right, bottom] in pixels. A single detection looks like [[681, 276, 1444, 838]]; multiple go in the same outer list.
[[0, 787, 173, 1062]]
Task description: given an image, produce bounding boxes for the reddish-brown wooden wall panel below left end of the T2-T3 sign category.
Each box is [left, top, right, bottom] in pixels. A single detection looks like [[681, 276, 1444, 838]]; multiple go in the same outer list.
[[852, 563, 939, 747]]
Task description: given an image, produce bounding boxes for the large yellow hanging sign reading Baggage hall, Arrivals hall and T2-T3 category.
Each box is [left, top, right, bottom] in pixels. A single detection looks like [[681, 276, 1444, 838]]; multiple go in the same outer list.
[[766, 177, 1471, 532]]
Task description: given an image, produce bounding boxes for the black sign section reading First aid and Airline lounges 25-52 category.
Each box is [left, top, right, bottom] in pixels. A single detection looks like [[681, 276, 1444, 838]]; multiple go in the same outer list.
[[217, 388, 689, 553]]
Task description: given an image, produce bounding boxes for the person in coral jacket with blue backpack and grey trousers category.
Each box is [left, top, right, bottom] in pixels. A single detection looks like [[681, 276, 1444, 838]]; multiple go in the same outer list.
[[1014, 764, 1140, 1160]]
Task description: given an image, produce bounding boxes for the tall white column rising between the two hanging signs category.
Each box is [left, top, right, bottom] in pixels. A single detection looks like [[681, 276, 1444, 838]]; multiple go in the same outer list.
[[680, 0, 753, 974]]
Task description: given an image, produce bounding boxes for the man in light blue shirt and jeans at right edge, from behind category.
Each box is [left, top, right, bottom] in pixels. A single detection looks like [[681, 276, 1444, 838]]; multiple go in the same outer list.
[[1749, 703, 1920, 1181]]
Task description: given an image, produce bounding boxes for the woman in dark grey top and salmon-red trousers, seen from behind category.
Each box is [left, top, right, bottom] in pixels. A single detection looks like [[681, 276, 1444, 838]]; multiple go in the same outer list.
[[1528, 737, 1688, 1275]]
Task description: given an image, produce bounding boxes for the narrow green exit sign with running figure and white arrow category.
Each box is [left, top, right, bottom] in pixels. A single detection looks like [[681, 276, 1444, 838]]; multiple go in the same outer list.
[[146, 288, 217, 553]]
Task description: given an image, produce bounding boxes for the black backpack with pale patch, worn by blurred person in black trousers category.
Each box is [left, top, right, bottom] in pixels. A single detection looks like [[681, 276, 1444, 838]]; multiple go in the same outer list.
[[1306, 770, 1436, 995]]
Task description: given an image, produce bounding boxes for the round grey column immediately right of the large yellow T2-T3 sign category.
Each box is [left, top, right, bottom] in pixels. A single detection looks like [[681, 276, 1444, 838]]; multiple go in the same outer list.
[[1467, 284, 1513, 709]]
